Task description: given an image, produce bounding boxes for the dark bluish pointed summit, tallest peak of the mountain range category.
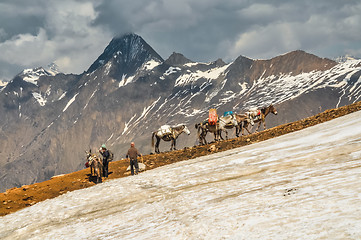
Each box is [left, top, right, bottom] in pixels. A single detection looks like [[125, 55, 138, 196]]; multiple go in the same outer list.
[[87, 33, 164, 73]]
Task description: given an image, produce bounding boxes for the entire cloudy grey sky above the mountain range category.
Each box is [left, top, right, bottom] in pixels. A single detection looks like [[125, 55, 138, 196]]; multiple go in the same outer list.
[[0, 0, 361, 80]]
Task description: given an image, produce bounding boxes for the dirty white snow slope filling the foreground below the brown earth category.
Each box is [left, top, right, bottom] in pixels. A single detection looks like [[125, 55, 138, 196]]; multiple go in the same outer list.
[[0, 111, 361, 239]]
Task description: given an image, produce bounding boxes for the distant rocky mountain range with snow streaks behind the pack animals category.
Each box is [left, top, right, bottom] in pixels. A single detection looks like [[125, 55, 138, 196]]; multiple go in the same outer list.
[[0, 34, 361, 191]]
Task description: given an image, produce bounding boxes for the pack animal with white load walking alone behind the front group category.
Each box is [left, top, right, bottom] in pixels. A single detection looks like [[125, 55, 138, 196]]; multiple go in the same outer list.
[[152, 124, 191, 153]]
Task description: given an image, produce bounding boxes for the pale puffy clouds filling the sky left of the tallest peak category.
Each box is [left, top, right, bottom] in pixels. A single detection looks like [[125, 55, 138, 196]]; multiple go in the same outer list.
[[0, 0, 112, 79]]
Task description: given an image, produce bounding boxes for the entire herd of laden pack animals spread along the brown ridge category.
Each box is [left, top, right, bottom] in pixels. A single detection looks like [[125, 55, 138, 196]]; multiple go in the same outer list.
[[86, 104, 277, 182]]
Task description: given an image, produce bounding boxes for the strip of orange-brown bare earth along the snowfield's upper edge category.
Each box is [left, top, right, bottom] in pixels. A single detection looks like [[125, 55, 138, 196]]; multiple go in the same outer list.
[[0, 102, 361, 216]]
